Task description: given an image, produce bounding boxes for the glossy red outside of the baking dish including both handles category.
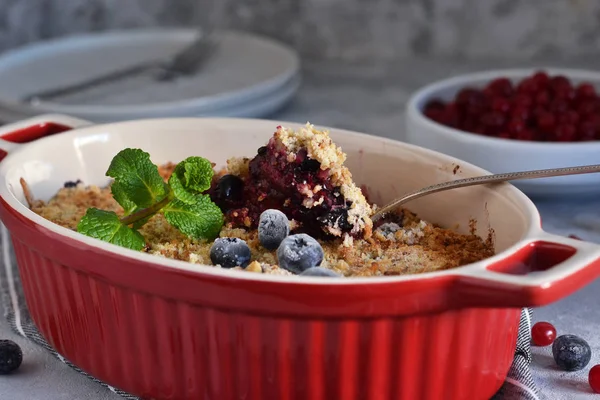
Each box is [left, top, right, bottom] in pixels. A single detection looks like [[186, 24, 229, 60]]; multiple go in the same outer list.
[[0, 115, 600, 400]]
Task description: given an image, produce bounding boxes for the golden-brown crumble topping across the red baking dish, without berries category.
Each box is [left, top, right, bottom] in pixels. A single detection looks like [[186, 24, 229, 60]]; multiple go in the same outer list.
[[23, 124, 494, 277]]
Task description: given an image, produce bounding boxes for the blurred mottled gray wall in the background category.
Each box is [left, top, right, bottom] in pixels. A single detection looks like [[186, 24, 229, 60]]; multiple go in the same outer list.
[[0, 0, 600, 60]]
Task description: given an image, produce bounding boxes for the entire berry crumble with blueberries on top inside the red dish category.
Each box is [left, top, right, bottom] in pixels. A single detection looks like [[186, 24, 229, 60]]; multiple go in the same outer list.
[[22, 124, 494, 277]]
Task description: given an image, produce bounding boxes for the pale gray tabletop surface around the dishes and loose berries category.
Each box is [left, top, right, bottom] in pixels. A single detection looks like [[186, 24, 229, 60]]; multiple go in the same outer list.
[[0, 60, 600, 400]]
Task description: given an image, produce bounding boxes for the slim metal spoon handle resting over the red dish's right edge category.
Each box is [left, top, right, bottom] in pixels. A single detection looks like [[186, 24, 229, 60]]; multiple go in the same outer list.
[[371, 164, 600, 221]]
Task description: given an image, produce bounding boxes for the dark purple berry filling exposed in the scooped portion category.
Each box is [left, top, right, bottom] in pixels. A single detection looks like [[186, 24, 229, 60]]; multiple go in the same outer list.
[[210, 138, 353, 238]]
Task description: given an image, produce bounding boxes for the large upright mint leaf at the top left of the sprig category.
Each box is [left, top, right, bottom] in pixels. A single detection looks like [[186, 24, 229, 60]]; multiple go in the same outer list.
[[106, 149, 169, 208]]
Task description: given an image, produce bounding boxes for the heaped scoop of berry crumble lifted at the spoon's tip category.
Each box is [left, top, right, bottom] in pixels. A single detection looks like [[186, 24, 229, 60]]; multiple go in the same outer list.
[[211, 124, 373, 237]]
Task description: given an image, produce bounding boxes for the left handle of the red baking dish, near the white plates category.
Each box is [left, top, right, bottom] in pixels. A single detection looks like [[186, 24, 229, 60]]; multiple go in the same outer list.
[[0, 114, 92, 160]]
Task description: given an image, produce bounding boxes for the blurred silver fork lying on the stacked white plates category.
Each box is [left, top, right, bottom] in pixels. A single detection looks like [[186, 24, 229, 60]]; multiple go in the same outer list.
[[23, 34, 216, 105]]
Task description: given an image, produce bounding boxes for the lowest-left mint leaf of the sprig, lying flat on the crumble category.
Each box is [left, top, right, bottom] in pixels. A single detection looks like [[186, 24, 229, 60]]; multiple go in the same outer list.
[[77, 208, 146, 251]]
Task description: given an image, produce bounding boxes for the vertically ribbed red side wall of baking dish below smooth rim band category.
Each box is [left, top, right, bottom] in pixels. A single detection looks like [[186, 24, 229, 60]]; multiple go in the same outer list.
[[13, 239, 520, 400]]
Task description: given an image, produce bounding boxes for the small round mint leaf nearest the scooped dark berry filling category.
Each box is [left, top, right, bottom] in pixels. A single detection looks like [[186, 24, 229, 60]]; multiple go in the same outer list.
[[169, 157, 213, 203]]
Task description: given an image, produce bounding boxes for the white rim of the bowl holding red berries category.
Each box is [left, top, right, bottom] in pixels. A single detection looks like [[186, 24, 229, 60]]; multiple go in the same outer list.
[[408, 67, 600, 151]]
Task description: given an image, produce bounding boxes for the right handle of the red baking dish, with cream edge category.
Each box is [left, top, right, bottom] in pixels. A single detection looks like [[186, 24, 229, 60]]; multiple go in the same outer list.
[[455, 231, 600, 308]]
